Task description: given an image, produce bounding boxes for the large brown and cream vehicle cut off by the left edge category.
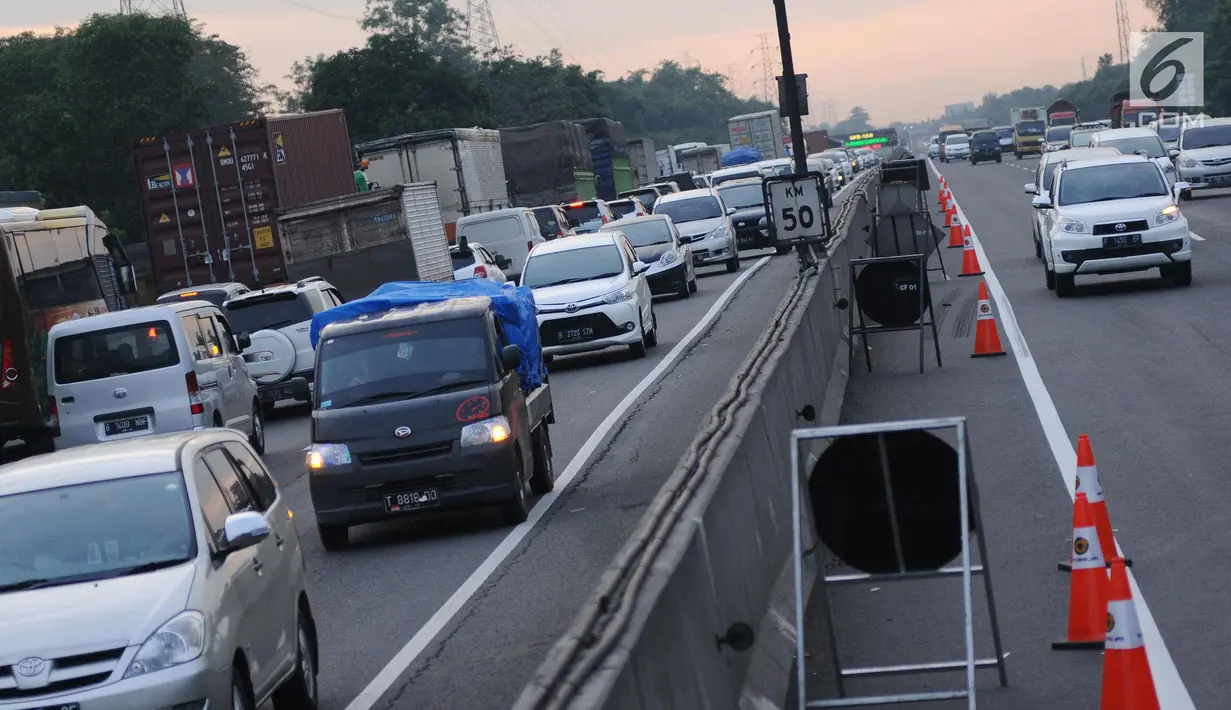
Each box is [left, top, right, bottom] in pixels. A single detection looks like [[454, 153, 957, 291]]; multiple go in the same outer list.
[[0, 207, 135, 453]]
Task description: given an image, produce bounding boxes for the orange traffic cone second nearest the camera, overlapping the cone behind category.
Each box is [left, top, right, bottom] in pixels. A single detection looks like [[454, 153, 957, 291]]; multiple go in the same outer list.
[[1051, 493, 1107, 651]]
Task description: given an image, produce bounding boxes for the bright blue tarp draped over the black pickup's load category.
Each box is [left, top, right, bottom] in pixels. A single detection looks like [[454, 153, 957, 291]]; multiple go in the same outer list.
[[309, 278, 547, 390]]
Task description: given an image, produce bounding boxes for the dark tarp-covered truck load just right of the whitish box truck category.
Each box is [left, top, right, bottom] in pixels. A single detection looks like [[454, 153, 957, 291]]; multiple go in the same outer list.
[[500, 121, 597, 207]]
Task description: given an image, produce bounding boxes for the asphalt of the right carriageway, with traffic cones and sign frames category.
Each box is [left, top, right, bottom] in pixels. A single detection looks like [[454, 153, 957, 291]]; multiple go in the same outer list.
[[808, 156, 1231, 710]]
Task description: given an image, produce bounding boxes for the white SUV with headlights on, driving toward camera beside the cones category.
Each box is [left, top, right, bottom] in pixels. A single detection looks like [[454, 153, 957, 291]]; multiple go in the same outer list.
[[1033, 155, 1193, 298]]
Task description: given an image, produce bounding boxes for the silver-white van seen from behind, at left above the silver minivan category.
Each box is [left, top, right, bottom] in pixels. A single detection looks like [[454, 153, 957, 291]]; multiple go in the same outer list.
[[47, 300, 285, 453]]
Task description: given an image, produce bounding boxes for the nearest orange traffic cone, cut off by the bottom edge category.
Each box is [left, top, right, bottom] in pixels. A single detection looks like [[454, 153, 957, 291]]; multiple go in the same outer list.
[[1099, 556, 1158, 710]]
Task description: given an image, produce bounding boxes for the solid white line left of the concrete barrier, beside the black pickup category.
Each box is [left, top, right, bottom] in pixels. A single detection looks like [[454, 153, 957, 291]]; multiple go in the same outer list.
[[346, 256, 772, 710]]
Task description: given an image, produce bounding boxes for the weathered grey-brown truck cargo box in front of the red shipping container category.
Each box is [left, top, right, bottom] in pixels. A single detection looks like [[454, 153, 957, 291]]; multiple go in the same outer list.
[[278, 182, 453, 300]]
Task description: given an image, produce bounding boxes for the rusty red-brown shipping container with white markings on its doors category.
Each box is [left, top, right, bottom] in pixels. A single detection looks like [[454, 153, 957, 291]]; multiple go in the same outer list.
[[133, 110, 355, 293]]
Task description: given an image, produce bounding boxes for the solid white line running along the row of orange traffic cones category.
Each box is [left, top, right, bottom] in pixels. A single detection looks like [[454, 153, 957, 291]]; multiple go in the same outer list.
[[928, 159, 1197, 710]]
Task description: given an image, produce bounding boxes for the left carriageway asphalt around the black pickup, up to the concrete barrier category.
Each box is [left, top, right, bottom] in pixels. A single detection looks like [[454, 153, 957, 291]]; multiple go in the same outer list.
[[251, 177, 861, 710]]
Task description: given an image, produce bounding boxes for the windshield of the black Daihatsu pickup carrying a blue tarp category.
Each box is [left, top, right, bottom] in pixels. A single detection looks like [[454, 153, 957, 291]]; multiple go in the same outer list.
[[316, 317, 495, 410]]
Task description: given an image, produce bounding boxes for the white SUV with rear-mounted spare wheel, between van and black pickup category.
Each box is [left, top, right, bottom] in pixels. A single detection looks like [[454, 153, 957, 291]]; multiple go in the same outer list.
[[223, 276, 345, 412]]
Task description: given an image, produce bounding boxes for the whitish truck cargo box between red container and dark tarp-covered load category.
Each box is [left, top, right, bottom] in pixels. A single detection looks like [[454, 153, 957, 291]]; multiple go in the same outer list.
[[355, 128, 512, 244]]
